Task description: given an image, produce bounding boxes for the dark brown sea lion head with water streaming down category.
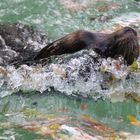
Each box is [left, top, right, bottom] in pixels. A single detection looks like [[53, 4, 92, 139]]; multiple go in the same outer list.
[[107, 27, 140, 65]]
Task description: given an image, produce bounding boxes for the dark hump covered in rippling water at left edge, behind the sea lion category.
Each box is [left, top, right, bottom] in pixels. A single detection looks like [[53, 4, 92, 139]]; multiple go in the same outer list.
[[0, 23, 48, 65]]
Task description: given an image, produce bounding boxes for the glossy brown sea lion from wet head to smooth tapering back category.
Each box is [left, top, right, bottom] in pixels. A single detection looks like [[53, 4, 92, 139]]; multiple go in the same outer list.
[[34, 27, 139, 65]]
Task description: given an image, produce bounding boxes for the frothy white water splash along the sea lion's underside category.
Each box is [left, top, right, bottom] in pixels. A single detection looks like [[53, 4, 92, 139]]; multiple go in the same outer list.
[[0, 50, 134, 99]]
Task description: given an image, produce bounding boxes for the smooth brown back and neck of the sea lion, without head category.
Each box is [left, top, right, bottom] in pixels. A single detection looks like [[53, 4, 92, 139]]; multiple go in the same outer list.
[[35, 30, 107, 59]]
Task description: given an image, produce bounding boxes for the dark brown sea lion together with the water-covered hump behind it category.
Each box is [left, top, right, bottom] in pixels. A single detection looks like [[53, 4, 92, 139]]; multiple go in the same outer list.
[[0, 23, 139, 65]]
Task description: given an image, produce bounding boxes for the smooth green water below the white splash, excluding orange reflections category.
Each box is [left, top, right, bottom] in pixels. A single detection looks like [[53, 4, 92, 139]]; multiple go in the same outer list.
[[0, 93, 140, 140]]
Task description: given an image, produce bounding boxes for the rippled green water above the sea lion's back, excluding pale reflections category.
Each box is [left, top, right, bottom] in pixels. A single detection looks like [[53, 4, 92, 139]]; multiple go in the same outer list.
[[0, 0, 140, 38]]
